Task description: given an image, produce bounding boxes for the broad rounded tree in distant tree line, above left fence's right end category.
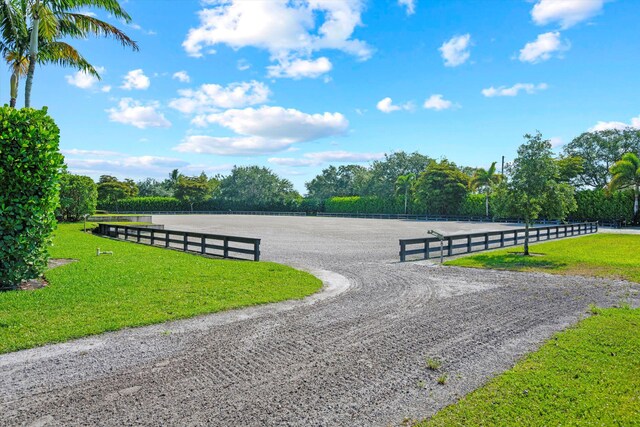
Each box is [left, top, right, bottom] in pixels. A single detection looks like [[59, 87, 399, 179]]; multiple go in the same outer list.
[[219, 166, 300, 210]]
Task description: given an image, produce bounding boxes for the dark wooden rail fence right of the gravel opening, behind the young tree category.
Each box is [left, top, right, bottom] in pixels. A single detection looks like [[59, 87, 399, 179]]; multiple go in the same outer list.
[[400, 222, 598, 262]]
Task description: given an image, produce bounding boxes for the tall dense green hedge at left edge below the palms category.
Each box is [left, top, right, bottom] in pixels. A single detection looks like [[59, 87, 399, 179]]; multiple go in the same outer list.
[[0, 107, 63, 288]]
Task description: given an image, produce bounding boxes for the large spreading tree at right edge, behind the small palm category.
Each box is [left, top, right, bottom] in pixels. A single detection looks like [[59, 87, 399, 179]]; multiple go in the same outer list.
[[564, 128, 640, 188]]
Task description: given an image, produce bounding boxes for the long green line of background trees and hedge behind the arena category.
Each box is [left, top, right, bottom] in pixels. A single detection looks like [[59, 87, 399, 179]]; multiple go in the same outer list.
[[61, 129, 640, 226]]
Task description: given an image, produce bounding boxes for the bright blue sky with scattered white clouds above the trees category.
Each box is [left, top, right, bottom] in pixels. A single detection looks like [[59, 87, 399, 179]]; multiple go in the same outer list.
[[17, 0, 640, 191]]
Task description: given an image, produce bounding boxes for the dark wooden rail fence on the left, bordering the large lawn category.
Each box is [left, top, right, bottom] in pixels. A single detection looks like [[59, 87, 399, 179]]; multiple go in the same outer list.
[[98, 224, 260, 261]]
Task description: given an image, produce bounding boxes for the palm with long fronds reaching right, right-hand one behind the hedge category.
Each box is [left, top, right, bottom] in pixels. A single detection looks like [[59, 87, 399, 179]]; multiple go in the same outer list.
[[21, 0, 138, 107]]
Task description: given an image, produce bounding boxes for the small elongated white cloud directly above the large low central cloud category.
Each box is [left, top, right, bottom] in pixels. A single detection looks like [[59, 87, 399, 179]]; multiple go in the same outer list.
[[169, 80, 271, 114]]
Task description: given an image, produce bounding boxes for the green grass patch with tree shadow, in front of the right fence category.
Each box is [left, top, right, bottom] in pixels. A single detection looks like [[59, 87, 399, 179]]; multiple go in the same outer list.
[[445, 234, 640, 282]]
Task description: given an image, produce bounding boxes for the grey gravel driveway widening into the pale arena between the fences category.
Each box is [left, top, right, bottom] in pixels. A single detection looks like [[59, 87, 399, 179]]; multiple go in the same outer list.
[[0, 215, 640, 426]]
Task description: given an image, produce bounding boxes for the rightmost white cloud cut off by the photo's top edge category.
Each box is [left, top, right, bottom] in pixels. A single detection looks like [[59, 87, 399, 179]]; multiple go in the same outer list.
[[531, 0, 606, 29]]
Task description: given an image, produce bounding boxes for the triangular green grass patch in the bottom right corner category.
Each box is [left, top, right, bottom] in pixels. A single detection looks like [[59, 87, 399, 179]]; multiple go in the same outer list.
[[417, 308, 640, 427]]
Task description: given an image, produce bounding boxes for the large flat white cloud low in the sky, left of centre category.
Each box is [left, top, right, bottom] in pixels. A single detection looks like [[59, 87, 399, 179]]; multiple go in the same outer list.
[[174, 106, 349, 155]]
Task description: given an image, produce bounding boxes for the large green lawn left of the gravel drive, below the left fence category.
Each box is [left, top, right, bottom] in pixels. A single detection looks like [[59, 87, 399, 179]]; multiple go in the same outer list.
[[0, 224, 322, 353]]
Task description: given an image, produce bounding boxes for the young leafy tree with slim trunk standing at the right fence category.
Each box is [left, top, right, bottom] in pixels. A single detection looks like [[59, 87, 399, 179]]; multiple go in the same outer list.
[[496, 132, 577, 255]]
